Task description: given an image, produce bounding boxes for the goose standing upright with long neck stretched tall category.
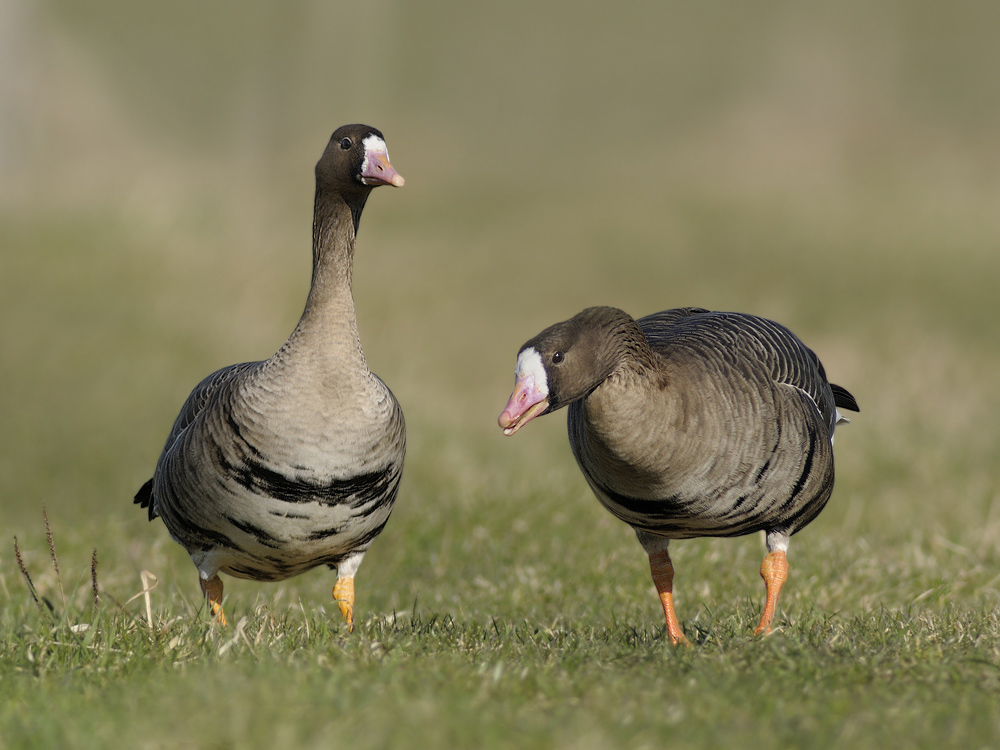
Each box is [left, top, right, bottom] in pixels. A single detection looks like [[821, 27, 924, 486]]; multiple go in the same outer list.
[[135, 125, 406, 630]]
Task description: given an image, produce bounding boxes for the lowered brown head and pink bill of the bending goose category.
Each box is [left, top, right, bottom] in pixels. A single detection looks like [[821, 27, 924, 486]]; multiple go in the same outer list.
[[498, 307, 642, 435]]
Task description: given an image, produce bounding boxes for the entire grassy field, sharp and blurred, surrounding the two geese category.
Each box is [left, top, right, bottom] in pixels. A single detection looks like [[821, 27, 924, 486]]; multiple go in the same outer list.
[[0, 0, 1000, 750]]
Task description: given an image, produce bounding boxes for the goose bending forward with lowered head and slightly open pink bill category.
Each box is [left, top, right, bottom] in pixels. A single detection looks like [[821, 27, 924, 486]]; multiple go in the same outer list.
[[499, 307, 859, 644]]
